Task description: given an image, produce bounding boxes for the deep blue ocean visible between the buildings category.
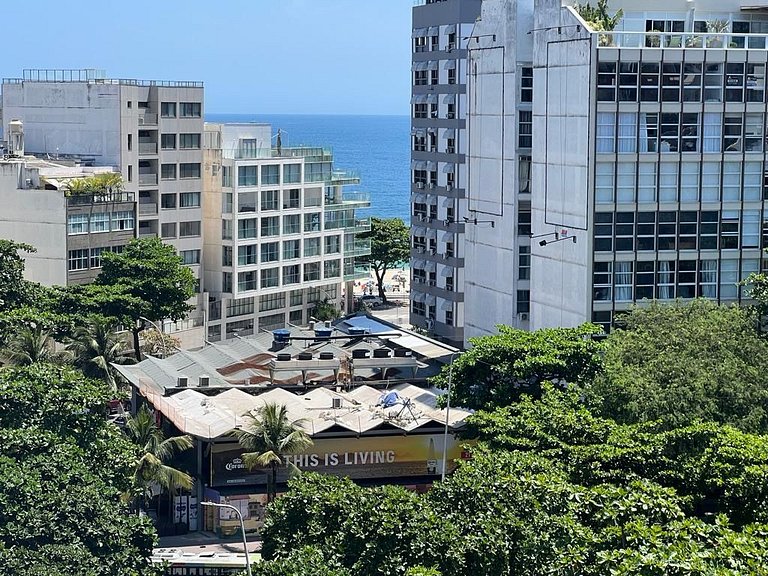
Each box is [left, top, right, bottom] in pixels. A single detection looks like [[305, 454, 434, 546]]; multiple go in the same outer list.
[[205, 114, 411, 223]]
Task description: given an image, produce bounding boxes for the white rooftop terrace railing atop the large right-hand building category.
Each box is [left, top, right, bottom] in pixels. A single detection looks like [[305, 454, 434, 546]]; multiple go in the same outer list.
[[593, 31, 768, 50]]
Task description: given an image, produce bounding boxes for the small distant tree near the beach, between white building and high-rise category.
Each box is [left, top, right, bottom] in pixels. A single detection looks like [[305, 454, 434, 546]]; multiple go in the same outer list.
[[360, 217, 411, 302]]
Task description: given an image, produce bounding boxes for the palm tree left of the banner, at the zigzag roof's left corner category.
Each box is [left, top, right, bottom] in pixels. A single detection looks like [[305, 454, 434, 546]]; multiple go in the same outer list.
[[125, 404, 194, 512]]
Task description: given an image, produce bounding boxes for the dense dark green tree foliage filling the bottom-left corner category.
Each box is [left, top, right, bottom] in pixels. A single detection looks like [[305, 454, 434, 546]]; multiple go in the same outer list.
[[0, 363, 154, 576]]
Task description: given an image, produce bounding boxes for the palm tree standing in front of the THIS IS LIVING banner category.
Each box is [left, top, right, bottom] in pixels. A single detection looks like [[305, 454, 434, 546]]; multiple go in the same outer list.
[[236, 402, 312, 502]]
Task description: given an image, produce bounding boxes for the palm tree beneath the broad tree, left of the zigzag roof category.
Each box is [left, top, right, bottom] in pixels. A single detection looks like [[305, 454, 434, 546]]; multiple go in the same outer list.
[[67, 318, 133, 392]]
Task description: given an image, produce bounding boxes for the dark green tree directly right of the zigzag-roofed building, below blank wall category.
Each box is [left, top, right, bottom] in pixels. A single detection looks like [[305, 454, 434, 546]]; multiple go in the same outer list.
[[432, 324, 602, 409]]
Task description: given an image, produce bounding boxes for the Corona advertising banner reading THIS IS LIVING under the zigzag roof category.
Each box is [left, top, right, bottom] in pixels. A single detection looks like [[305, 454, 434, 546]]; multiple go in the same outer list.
[[210, 434, 462, 486]]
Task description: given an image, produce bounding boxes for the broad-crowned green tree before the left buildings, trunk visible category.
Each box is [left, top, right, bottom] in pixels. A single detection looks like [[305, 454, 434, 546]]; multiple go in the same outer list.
[[93, 238, 195, 360]]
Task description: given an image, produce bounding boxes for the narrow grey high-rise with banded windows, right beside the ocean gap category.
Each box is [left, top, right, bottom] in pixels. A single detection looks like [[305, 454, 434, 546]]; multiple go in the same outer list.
[[410, 0, 481, 344]]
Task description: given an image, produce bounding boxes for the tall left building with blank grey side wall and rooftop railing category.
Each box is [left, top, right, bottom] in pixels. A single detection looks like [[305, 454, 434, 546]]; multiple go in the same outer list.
[[2, 69, 203, 310]]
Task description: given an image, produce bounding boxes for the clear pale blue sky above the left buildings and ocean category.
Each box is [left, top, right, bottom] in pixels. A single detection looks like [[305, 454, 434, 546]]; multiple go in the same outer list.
[[0, 0, 413, 115]]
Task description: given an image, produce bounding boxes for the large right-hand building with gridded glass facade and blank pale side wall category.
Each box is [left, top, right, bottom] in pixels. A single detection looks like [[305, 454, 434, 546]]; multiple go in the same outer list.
[[465, 0, 768, 336]]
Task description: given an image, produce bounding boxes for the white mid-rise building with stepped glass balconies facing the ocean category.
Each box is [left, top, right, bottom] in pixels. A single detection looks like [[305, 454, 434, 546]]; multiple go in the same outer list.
[[204, 124, 371, 342]]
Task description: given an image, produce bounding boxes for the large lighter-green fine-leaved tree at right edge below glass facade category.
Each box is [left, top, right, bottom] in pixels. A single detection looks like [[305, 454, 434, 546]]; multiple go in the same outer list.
[[588, 299, 768, 433]]
